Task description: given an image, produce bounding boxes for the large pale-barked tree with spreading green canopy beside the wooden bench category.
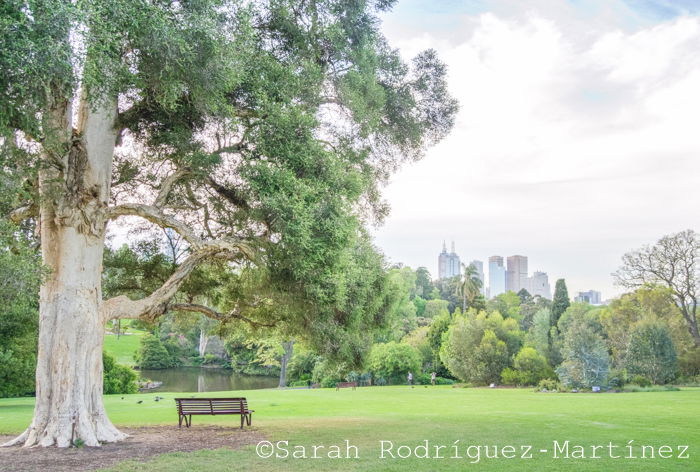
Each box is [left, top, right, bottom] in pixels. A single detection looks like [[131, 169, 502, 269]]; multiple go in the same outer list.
[[0, 0, 457, 447]]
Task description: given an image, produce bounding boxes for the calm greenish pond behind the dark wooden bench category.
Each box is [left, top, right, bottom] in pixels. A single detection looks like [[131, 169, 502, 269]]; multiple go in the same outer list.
[[140, 367, 279, 392]]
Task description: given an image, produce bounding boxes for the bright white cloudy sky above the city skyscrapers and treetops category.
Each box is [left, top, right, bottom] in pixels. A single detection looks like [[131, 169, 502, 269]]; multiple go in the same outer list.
[[375, 0, 700, 298]]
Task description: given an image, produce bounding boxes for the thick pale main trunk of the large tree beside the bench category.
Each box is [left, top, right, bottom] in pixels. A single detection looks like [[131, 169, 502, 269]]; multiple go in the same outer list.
[[7, 101, 127, 447]]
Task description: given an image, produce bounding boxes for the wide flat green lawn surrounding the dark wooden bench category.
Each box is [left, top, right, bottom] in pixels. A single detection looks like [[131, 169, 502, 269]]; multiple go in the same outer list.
[[0, 386, 700, 472]]
